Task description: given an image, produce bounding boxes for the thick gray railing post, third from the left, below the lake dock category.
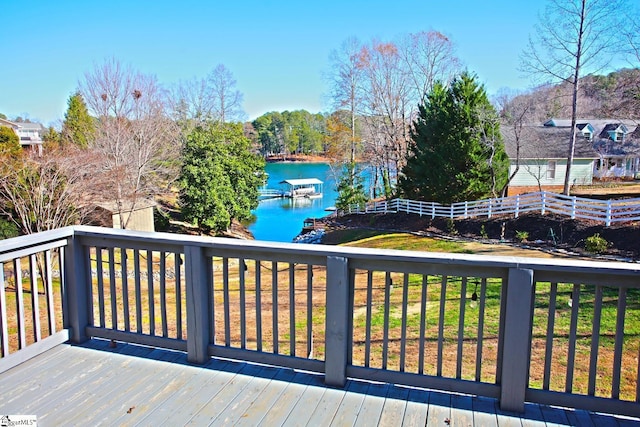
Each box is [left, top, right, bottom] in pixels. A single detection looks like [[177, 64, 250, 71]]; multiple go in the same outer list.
[[324, 256, 350, 387]]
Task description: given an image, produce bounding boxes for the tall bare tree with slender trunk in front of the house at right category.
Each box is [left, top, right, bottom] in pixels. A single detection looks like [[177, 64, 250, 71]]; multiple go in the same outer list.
[[522, 0, 626, 195]]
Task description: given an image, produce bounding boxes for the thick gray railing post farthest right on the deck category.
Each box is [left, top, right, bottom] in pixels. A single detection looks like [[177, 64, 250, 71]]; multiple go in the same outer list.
[[500, 268, 533, 412]]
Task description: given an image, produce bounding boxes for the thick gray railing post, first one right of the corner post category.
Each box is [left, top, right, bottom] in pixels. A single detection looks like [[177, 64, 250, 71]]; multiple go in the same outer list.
[[184, 246, 213, 364]]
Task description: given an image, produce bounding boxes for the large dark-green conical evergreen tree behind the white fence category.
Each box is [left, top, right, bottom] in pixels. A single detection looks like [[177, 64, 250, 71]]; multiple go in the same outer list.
[[399, 73, 509, 204]]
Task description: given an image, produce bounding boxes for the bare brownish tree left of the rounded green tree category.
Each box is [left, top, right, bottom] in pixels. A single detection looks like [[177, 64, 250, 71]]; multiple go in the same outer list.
[[80, 59, 180, 228]]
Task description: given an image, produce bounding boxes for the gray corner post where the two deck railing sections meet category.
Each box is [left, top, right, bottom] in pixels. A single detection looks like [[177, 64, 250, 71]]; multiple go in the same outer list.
[[64, 235, 93, 343]]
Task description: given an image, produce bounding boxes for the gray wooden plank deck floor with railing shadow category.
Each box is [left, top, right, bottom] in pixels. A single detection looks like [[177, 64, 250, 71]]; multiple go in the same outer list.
[[0, 340, 640, 426]]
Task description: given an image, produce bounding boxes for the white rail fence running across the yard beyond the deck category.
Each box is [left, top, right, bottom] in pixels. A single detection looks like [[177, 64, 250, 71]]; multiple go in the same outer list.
[[346, 191, 640, 227]]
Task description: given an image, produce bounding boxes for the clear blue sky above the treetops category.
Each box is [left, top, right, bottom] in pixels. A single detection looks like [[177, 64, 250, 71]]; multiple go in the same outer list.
[[0, 0, 580, 125]]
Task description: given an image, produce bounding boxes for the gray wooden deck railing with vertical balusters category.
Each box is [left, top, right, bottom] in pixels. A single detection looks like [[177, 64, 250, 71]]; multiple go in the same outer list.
[[0, 227, 640, 416]]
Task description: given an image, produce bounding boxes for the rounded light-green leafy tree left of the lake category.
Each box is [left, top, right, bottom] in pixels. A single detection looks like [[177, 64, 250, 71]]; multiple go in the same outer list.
[[180, 124, 264, 232]]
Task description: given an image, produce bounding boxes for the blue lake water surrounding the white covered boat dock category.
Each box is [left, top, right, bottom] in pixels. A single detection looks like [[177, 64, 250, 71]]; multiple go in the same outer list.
[[249, 163, 338, 242]]
